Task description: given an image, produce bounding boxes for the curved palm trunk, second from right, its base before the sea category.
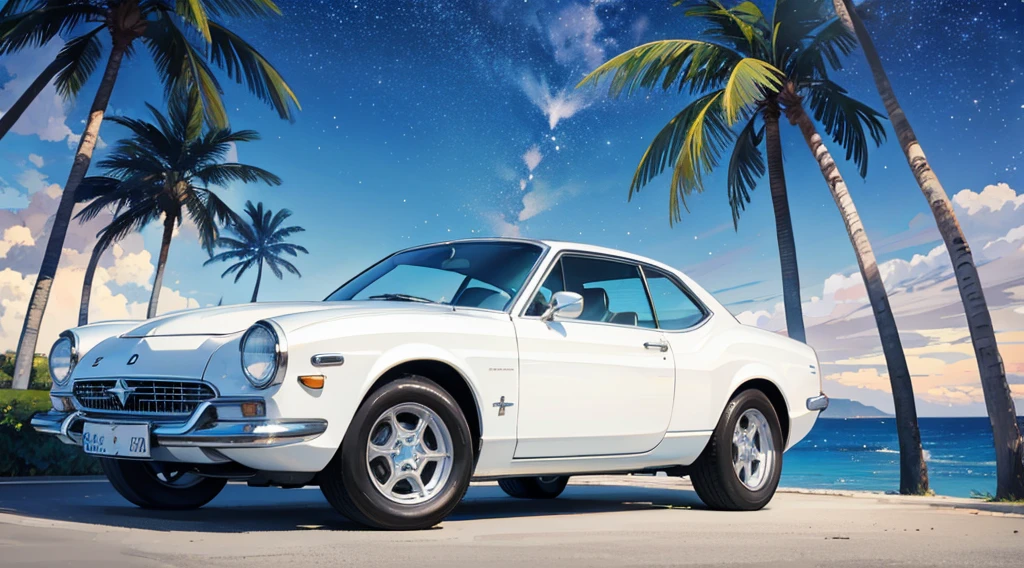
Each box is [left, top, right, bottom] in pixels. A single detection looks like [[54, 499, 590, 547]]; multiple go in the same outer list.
[[786, 92, 928, 495]]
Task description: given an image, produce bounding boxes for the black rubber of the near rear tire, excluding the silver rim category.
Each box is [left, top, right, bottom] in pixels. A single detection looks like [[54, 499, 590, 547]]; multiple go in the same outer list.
[[690, 389, 783, 511]]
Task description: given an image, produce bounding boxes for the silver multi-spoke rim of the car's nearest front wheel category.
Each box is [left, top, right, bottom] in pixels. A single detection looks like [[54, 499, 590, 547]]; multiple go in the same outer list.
[[367, 402, 455, 505]]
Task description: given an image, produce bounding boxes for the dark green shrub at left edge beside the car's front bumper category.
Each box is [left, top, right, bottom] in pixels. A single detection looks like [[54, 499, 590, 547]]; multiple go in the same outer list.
[[0, 390, 101, 477]]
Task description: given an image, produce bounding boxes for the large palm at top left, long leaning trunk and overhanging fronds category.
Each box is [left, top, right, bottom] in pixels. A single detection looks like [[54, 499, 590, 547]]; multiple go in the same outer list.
[[0, 0, 299, 389]]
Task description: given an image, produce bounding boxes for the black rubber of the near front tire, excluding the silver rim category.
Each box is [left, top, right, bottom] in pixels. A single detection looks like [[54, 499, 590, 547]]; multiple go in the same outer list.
[[319, 375, 473, 530]]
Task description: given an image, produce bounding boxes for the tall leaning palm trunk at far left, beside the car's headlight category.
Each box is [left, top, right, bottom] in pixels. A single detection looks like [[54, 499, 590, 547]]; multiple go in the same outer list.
[[12, 42, 128, 389]]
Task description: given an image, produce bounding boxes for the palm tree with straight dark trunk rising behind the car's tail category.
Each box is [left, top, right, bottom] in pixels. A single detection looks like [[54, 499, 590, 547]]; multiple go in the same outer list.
[[577, 2, 823, 342]]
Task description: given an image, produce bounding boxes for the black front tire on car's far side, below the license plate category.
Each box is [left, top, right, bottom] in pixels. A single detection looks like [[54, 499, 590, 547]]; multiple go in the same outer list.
[[99, 457, 227, 511]]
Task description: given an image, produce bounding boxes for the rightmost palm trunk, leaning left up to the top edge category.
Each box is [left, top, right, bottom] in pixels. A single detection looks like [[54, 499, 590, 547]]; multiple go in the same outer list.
[[834, 0, 1024, 499]]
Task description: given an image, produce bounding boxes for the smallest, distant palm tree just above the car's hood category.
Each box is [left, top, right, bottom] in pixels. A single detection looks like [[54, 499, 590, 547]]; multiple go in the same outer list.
[[203, 202, 309, 302]]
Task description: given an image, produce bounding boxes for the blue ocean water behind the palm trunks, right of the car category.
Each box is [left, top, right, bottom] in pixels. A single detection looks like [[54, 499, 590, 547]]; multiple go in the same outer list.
[[779, 418, 1024, 497]]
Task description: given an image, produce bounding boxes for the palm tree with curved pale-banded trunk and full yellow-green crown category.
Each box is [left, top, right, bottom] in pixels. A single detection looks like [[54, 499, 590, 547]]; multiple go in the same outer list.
[[581, 0, 928, 494]]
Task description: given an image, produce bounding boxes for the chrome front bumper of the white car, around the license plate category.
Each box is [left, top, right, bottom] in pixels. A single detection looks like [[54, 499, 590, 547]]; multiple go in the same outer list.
[[31, 399, 327, 448]]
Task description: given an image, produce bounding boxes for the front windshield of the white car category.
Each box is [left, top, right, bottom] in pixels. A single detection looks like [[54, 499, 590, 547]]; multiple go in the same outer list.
[[327, 242, 543, 311]]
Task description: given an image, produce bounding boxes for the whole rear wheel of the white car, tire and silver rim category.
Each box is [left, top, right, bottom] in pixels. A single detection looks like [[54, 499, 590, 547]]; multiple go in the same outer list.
[[690, 389, 784, 511]]
